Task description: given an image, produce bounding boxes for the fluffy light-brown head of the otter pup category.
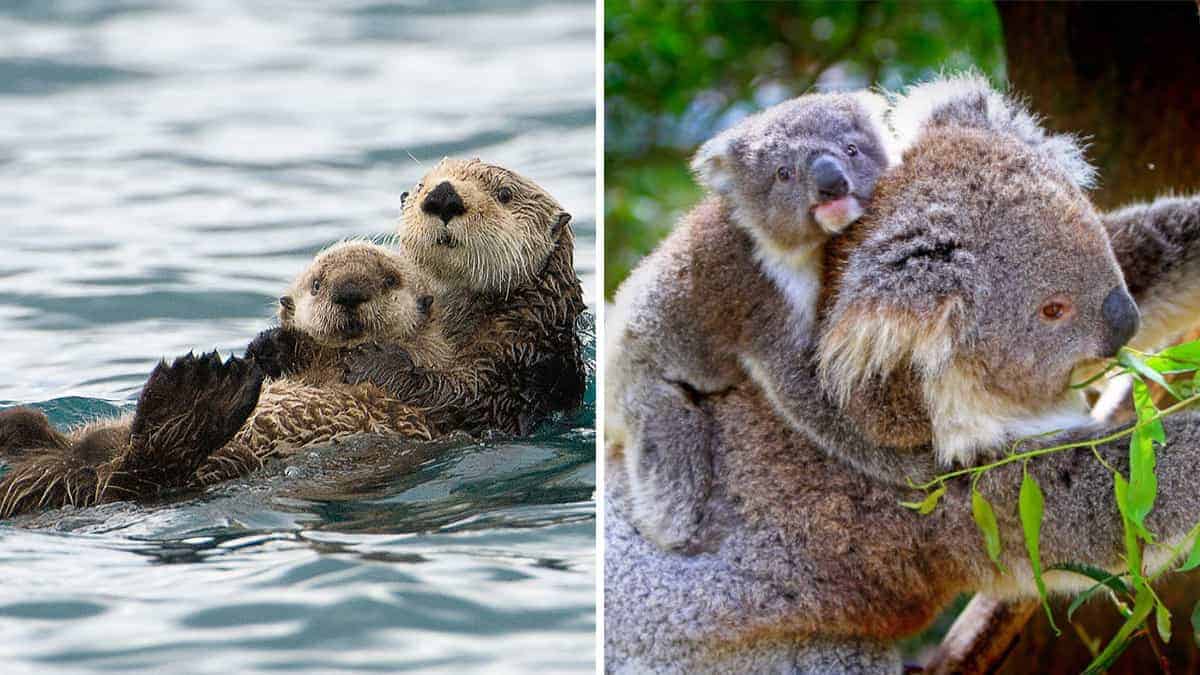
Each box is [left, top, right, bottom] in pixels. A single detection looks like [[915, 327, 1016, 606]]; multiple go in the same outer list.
[[280, 241, 433, 347]]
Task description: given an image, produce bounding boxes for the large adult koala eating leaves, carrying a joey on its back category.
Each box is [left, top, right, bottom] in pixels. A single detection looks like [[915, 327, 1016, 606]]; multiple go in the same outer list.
[[605, 79, 1200, 673]]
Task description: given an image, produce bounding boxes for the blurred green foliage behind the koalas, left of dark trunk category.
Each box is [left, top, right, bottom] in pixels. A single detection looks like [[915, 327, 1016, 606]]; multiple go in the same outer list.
[[605, 0, 1004, 298]]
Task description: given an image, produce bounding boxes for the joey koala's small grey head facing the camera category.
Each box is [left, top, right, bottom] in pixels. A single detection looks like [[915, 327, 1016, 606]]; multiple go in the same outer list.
[[691, 92, 892, 264]]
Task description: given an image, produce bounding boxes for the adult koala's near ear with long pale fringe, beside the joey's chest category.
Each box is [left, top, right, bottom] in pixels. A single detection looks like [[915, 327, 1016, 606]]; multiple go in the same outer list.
[[818, 207, 974, 405]]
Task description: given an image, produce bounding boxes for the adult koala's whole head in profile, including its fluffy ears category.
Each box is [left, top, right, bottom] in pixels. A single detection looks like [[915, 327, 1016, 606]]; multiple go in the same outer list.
[[820, 73, 1138, 464]]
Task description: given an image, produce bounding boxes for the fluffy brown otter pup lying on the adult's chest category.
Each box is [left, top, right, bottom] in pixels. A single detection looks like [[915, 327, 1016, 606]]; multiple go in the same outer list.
[[192, 241, 454, 485]]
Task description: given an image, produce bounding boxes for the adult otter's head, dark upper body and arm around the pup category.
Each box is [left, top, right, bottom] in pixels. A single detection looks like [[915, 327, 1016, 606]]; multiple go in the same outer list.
[[343, 159, 587, 435]]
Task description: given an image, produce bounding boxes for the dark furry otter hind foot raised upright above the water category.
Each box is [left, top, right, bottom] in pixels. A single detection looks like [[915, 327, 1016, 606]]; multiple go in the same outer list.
[[132, 352, 264, 473]]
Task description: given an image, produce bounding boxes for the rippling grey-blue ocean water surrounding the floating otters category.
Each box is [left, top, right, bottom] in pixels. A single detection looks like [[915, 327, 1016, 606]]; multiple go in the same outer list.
[[0, 0, 596, 674]]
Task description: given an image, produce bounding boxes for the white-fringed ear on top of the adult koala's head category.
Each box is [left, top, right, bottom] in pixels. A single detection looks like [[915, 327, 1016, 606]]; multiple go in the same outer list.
[[892, 72, 1096, 190]]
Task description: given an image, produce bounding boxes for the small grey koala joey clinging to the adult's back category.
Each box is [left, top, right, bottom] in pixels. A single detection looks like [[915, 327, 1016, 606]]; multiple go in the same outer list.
[[605, 92, 890, 548]]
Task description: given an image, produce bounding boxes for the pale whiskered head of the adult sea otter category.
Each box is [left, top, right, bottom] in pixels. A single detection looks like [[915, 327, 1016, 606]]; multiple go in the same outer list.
[[400, 159, 571, 293]]
